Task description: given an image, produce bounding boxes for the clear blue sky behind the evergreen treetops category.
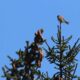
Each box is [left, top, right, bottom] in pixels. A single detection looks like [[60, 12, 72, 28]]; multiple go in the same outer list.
[[0, 0, 80, 80]]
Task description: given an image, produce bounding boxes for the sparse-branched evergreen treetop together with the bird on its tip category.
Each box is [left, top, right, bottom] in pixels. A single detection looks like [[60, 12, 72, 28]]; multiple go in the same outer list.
[[44, 15, 80, 80]]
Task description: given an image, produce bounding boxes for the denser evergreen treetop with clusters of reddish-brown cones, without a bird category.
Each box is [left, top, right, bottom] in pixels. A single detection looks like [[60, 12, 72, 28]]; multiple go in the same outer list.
[[2, 29, 45, 80]]
